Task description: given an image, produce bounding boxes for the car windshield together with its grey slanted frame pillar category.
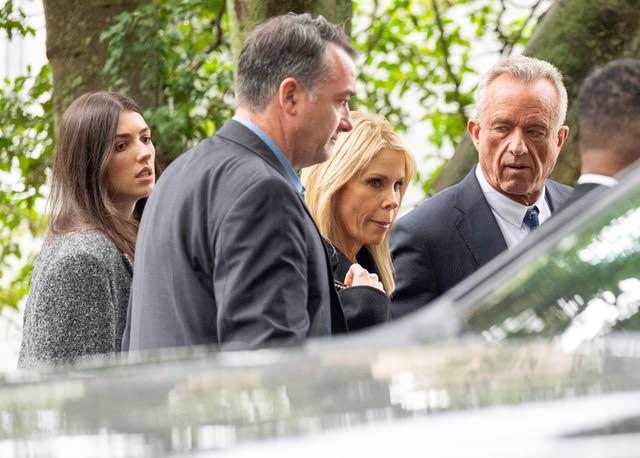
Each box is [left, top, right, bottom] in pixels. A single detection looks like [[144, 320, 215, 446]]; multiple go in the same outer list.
[[363, 167, 640, 350]]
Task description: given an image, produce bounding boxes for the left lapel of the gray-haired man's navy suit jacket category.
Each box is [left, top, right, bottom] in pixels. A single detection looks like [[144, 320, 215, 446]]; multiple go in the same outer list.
[[454, 167, 507, 266]]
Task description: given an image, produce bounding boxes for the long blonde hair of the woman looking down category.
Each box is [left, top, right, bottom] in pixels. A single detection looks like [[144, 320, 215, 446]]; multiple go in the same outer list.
[[302, 111, 416, 295]]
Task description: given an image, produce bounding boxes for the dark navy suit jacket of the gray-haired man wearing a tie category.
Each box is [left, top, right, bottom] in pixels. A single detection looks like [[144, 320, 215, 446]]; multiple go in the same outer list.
[[391, 167, 572, 318]]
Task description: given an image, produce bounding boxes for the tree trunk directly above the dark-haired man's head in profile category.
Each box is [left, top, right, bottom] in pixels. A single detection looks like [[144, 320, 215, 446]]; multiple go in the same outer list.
[[227, 0, 352, 60]]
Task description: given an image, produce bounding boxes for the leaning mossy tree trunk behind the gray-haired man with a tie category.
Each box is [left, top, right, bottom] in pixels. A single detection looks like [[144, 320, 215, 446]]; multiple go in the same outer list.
[[433, 0, 640, 192]]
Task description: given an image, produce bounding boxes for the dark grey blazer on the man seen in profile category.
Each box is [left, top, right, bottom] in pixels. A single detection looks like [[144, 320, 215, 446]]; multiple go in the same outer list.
[[123, 120, 346, 350]]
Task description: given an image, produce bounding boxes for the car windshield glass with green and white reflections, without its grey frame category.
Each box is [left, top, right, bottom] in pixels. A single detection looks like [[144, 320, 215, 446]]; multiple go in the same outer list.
[[464, 169, 640, 350]]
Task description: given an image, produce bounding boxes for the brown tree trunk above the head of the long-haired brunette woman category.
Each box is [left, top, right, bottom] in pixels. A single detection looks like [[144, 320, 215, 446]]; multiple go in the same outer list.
[[43, 0, 151, 119]]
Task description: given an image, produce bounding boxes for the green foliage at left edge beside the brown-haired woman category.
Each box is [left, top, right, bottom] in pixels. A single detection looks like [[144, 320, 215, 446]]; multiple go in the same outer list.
[[0, 66, 53, 308]]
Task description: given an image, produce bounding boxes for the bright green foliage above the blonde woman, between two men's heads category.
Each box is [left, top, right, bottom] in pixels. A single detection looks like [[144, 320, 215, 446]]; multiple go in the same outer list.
[[353, 0, 544, 193]]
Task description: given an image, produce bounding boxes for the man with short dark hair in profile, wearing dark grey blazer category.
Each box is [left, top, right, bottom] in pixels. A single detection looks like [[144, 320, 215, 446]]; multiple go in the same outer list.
[[123, 14, 356, 350]]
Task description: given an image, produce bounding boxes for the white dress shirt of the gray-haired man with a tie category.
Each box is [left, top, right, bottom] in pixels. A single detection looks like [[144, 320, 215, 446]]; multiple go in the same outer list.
[[476, 165, 551, 248]]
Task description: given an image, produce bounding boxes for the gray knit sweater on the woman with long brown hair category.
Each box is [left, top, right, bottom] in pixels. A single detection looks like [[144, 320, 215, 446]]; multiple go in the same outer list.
[[18, 231, 133, 367]]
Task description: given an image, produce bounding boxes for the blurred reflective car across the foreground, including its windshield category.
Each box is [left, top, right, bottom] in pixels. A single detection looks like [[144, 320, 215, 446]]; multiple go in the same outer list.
[[0, 164, 640, 458]]
